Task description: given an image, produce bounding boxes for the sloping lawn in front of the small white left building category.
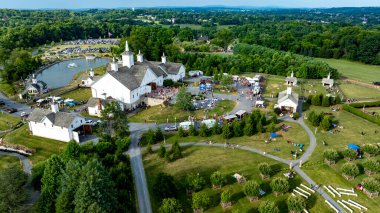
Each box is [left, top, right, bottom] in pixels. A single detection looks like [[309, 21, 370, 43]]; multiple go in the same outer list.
[[4, 125, 67, 164]]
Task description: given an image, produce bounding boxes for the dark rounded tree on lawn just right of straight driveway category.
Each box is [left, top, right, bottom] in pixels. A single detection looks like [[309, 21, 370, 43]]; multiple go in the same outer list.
[[152, 172, 177, 200]]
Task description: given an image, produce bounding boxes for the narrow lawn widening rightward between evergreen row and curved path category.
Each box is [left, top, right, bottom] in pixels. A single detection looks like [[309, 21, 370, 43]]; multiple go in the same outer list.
[[165, 122, 310, 160]]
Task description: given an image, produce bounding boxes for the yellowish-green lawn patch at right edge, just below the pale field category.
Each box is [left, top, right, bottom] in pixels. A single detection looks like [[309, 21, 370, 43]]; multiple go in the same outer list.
[[339, 83, 380, 100]]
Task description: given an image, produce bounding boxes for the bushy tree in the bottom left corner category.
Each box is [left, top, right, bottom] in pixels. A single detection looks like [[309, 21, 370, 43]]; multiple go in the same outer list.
[[0, 167, 28, 212]]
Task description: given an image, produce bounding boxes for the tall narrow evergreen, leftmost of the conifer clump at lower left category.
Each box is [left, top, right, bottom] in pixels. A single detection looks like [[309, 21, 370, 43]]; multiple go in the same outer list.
[[38, 155, 64, 212]]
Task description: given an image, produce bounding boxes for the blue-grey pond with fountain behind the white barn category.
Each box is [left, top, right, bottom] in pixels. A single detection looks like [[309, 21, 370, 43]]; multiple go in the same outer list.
[[37, 58, 110, 89]]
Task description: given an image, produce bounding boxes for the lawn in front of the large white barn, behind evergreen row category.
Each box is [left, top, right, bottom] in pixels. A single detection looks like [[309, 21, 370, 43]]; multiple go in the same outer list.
[[129, 100, 236, 123]]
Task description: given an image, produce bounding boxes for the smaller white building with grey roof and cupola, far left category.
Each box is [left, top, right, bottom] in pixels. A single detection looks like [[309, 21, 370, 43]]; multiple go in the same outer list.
[[28, 105, 85, 142]]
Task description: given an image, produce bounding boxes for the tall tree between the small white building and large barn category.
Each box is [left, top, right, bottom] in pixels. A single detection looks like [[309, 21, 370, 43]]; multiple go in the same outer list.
[[100, 101, 129, 138]]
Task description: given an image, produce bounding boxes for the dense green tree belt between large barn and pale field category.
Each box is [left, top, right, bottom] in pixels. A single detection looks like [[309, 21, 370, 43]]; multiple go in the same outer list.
[[171, 44, 338, 78]]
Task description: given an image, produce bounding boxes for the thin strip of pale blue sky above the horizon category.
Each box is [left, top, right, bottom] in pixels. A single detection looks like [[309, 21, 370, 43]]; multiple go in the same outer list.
[[0, 0, 380, 9]]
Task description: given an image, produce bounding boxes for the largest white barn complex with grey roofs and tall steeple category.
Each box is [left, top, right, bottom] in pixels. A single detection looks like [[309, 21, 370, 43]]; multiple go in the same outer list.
[[91, 42, 185, 109]]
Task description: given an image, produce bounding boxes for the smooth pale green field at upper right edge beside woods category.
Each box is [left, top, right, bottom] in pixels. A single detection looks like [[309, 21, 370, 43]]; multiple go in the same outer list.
[[319, 59, 380, 83]]
